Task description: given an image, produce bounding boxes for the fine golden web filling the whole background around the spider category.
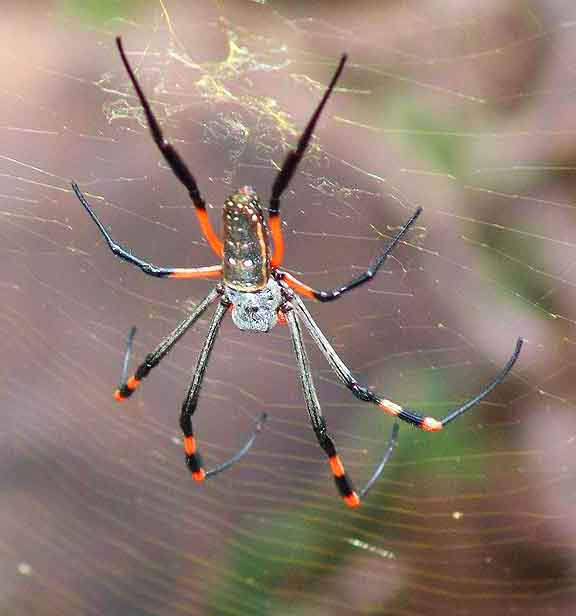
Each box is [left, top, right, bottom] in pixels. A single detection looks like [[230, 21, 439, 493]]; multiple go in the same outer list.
[[0, 0, 576, 616]]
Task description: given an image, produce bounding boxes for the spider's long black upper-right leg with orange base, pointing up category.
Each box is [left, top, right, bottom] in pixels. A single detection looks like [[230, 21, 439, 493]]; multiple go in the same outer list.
[[268, 54, 347, 267]]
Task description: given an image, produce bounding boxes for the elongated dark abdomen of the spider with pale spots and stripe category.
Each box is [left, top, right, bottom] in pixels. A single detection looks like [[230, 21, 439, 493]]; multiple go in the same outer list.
[[222, 186, 270, 292]]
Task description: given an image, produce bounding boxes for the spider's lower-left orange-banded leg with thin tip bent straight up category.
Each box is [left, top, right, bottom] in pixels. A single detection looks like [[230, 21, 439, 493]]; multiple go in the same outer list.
[[114, 289, 220, 402]]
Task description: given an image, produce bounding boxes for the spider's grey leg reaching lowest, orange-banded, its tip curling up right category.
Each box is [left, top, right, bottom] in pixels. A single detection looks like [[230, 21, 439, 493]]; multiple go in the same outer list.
[[284, 309, 398, 507]]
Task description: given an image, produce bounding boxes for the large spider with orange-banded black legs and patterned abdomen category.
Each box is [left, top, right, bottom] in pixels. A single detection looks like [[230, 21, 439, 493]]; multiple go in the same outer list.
[[72, 37, 523, 507]]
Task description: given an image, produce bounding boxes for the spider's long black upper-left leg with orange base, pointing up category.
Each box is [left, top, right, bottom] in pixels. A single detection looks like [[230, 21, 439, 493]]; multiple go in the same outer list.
[[116, 36, 223, 257]]
